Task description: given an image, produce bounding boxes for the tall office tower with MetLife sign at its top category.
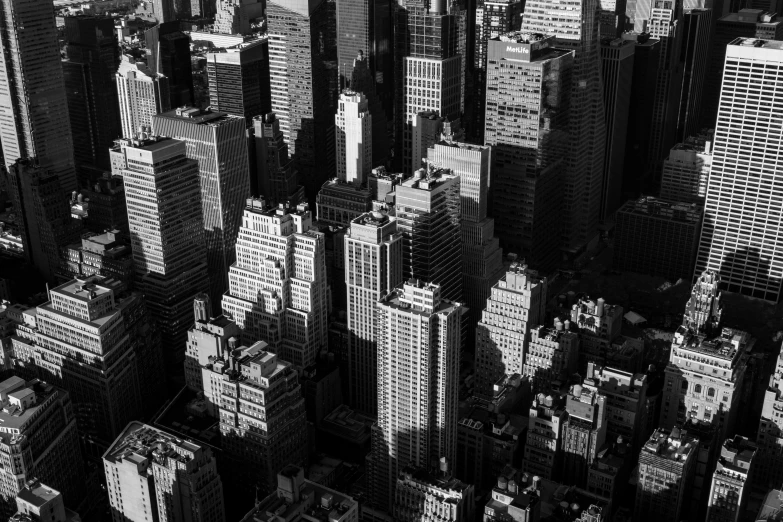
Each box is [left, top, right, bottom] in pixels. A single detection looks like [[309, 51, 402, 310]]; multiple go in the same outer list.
[[484, 32, 574, 270]]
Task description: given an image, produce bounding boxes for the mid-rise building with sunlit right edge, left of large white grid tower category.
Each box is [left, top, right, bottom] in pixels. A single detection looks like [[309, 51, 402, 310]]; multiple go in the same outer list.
[[661, 132, 713, 204]]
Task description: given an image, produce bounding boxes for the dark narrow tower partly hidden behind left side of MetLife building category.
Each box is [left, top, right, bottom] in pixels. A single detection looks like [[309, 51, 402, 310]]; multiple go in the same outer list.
[[472, 0, 525, 143]]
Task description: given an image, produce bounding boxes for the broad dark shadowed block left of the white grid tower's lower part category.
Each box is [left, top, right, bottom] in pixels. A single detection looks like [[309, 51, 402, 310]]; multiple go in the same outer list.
[[614, 197, 703, 281]]
